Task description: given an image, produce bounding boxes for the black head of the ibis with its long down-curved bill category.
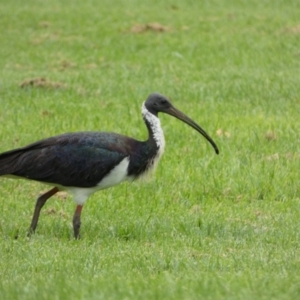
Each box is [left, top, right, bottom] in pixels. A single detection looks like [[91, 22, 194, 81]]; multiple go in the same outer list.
[[145, 93, 219, 154]]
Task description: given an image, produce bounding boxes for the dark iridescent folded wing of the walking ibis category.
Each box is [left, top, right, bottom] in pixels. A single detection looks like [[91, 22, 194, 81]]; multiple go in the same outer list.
[[0, 132, 138, 187]]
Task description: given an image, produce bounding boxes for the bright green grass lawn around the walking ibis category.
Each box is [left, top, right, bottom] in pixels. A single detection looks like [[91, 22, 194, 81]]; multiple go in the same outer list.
[[0, 0, 300, 300]]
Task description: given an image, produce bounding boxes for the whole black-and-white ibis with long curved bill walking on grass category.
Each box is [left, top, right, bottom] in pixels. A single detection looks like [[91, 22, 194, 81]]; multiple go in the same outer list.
[[0, 93, 219, 239]]
